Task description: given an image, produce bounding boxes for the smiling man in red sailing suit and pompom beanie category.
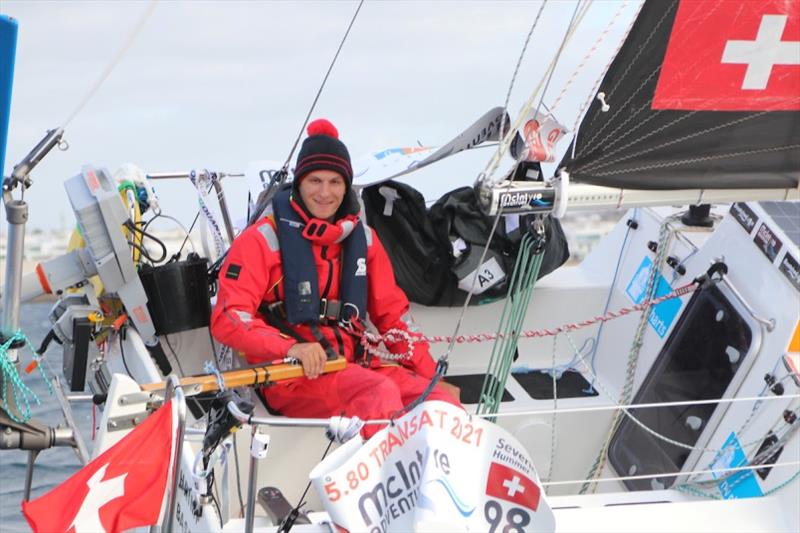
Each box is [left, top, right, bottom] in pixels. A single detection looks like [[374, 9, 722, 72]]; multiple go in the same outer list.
[[211, 119, 459, 437]]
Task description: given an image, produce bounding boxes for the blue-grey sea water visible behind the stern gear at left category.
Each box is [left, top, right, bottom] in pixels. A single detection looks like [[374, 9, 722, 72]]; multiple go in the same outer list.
[[0, 302, 93, 533]]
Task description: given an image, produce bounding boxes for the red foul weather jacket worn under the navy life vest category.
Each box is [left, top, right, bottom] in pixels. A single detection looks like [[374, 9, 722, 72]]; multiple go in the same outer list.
[[211, 217, 436, 378]]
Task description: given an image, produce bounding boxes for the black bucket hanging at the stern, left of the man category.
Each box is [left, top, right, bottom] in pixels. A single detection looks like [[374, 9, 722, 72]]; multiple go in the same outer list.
[[139, 254, 211, 335]]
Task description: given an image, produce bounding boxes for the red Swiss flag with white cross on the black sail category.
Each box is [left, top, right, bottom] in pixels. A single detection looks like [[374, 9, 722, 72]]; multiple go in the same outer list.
[[653, 0, 800, 111]]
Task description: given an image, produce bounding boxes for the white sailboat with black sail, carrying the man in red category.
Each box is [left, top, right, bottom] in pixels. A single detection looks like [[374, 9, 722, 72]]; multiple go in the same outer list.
[[0, 0, 800, 531]]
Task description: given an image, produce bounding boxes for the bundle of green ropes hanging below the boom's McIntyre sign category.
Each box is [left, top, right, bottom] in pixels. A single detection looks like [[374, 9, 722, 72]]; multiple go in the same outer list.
[[477, 233, 544, 421]]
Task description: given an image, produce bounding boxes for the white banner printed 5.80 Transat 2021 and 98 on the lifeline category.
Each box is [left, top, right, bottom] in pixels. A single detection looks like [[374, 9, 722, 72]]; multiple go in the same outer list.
[[310, 401, 555, 533]]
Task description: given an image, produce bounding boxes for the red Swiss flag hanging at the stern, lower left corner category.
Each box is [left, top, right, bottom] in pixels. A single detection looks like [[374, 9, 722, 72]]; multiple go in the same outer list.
[[22, 396, 175, 533]]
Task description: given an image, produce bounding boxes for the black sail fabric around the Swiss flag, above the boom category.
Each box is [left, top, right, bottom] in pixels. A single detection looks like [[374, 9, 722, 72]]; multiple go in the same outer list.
[[560, 0, 800, 189]]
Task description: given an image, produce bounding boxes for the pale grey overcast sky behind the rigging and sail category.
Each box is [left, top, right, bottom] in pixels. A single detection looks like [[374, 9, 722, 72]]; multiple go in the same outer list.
[[0, 0, 638, 228]]
